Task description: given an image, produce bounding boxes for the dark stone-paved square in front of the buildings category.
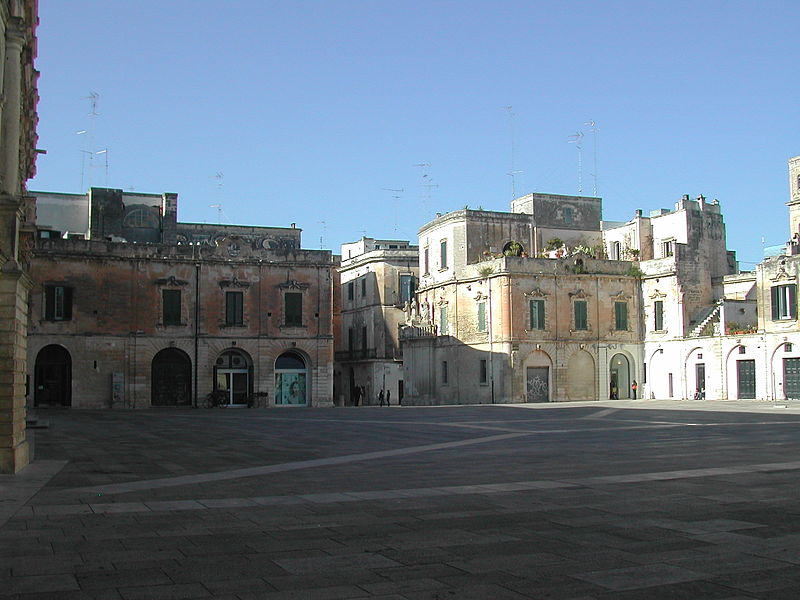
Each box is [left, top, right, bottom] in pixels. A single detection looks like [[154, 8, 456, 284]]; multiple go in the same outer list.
[[0, 401, 800, 600]]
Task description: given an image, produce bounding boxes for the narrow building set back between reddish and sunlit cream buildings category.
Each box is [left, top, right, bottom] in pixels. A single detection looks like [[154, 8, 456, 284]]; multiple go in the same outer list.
[[336, 237, 419, 405]]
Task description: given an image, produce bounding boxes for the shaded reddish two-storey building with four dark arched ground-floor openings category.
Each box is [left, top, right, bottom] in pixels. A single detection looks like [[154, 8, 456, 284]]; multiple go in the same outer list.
[[28, 188, 333, 408]]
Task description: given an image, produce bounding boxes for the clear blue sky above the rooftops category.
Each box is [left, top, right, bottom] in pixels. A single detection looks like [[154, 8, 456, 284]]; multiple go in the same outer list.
[[29, 0, 800, 268]]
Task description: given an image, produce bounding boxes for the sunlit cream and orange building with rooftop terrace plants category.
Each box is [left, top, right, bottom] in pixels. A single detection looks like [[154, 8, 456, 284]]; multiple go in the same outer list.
[[402, 194, 643, 404]]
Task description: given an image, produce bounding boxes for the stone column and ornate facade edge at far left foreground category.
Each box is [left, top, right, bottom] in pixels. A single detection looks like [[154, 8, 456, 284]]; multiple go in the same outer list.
[[0, 0, 39, 473]]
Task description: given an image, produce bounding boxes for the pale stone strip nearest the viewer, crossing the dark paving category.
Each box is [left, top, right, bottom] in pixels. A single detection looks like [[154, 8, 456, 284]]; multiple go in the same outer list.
[[21, 461, 800, 517]]
